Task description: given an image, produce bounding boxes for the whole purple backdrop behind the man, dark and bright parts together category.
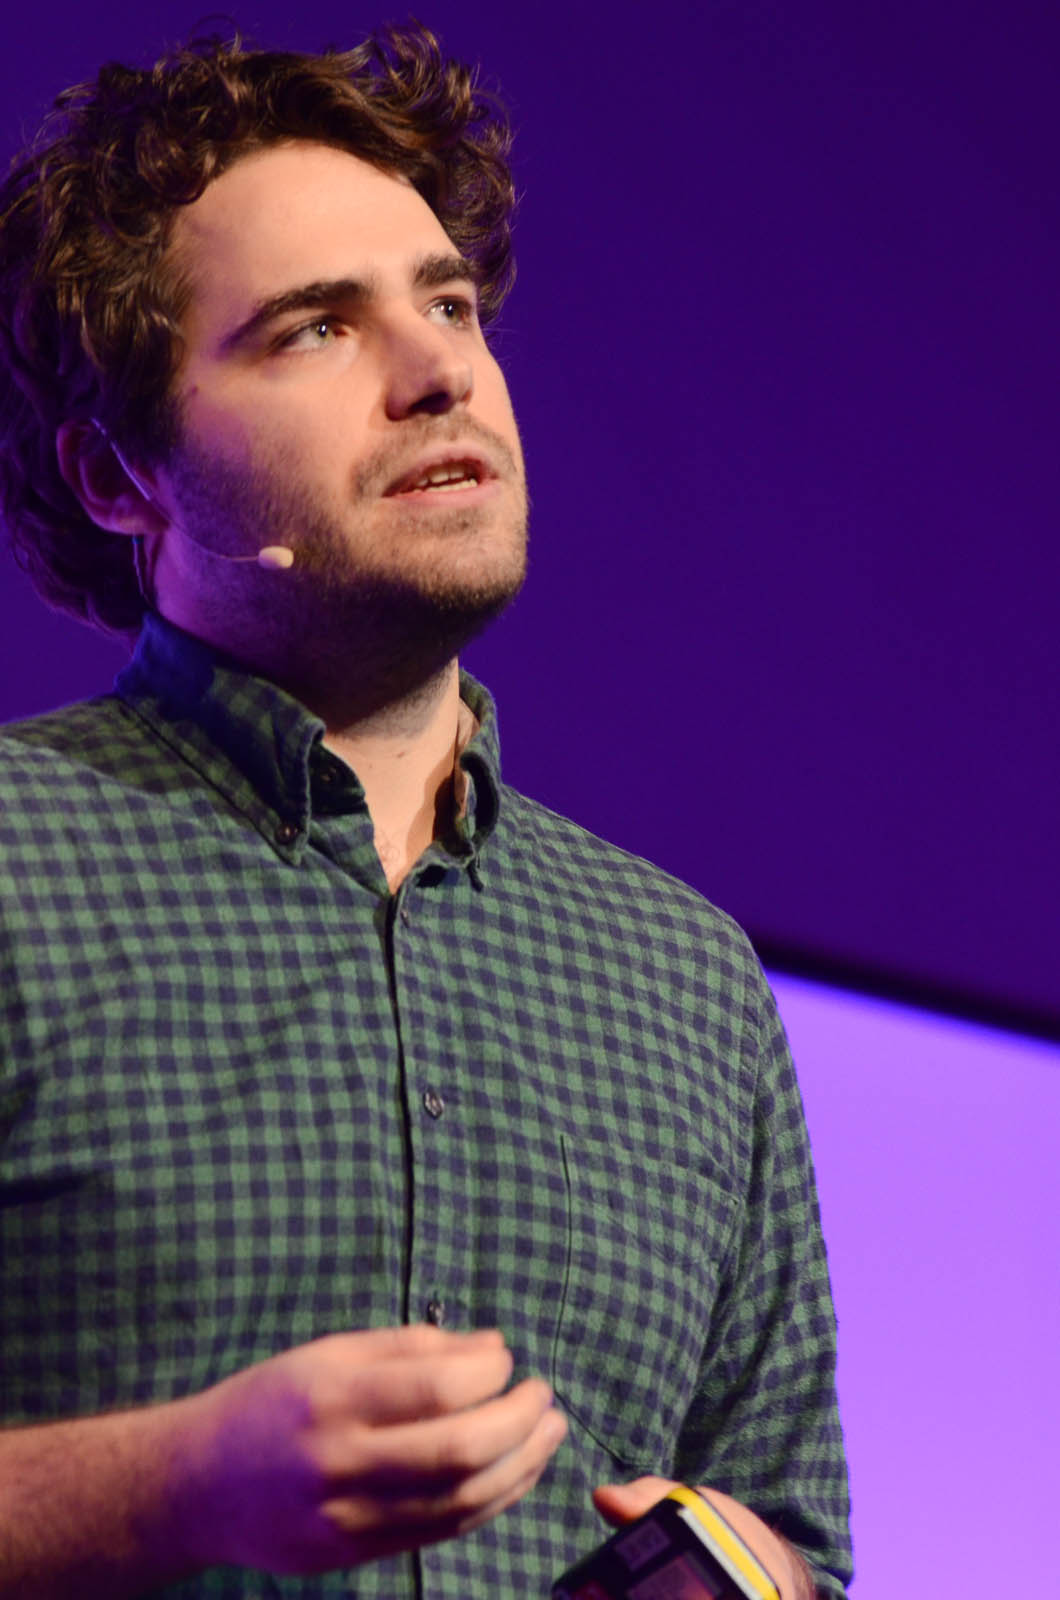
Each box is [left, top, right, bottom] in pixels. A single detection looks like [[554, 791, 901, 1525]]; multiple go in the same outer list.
[[0, 0, 1060, 1600]]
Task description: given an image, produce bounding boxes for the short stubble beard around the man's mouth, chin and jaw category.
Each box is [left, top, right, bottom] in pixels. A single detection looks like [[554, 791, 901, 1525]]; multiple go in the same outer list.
[[170, 418, 527, 709]]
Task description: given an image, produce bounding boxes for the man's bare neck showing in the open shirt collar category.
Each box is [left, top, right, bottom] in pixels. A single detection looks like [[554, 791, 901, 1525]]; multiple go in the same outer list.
[[323, 661, 460, 893]]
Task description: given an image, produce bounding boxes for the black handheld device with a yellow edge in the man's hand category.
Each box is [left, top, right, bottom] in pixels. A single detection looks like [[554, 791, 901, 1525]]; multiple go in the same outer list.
[[552, 1485, 780, 1600]]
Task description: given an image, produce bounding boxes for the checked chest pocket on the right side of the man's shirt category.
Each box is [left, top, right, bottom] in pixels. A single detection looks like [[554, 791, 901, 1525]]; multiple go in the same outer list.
[[551, 1139, 737, 1472]]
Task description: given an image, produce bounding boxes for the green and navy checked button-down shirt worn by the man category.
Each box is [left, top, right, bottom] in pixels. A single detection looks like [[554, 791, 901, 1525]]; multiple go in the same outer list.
[[0, 621, 849, 1600]]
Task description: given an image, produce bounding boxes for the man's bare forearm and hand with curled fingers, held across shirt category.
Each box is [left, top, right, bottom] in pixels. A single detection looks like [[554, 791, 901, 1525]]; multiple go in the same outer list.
[[0, 1326, 567, 1600]]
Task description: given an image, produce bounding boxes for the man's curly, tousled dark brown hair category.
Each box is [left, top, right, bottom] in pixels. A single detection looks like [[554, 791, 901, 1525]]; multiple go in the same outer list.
[[0, 26, 514, 634]]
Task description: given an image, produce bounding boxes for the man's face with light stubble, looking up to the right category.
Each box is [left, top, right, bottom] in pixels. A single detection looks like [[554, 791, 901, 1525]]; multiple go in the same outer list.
[[151, 142, 525, 684]]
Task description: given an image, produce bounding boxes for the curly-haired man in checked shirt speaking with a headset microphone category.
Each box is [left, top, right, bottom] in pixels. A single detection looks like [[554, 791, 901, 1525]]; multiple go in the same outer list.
[[0, 30, 849, 1600]]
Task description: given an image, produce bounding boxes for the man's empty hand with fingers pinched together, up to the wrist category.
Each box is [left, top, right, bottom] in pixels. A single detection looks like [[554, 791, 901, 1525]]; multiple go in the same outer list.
[[179, 1326, 567, 1573]]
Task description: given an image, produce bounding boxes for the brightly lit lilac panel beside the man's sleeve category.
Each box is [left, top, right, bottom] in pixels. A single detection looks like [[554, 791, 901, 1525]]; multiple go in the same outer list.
[[773, 974, 1060, 1600]]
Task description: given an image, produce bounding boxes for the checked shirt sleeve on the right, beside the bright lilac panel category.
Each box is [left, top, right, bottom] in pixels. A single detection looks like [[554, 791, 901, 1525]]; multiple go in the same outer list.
[[677, 970, 852, 1597]]
